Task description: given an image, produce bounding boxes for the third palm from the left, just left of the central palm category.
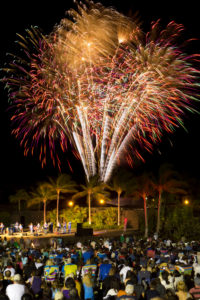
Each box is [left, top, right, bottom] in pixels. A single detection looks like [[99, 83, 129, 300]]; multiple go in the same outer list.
[[49, 174, 77, 224]]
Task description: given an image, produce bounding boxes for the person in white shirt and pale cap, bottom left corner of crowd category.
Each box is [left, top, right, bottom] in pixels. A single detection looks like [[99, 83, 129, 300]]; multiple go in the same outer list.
[[6, 274, 28, 300]]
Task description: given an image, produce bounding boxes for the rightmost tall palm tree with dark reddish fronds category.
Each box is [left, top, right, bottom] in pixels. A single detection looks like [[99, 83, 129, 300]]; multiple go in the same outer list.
[[153, 164, 187, 234]]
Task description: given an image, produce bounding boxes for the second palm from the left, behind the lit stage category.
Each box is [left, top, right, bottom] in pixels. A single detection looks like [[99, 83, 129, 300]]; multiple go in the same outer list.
[[27, 182, 56, 224]]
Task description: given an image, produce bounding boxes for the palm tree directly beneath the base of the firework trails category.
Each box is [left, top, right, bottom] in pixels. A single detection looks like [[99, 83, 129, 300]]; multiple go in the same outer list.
[[72, 176, 107, 225]]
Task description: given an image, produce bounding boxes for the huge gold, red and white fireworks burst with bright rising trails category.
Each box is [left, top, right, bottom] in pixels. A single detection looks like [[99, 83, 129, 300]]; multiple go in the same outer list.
[[3, 2, 199, 182]]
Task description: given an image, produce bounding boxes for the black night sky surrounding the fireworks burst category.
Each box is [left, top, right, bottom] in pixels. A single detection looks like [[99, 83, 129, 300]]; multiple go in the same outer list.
[[0, 0, 200, 202]]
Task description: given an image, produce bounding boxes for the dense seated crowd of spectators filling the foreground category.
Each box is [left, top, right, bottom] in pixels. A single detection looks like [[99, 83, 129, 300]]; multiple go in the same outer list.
[[0, 235, 200, 300]]
